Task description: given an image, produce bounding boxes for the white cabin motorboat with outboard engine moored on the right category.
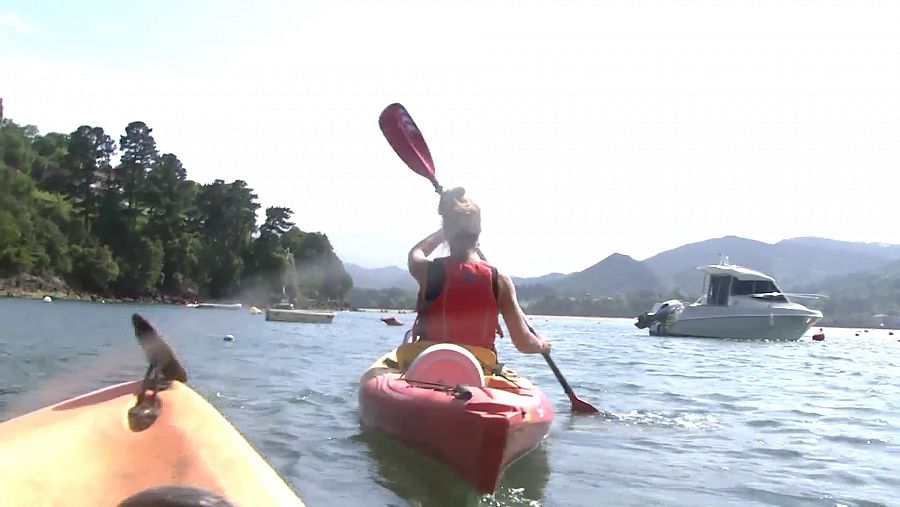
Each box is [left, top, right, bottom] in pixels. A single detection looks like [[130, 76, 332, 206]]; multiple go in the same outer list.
[[634, 257, 827, 340]]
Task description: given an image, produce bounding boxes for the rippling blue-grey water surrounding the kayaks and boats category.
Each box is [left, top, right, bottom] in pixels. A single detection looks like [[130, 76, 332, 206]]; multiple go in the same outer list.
[[0, 299, 900, 506]]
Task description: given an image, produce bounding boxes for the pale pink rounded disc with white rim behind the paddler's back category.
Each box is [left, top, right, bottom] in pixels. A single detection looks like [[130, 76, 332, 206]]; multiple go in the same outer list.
[[405, 343, 485, 387]]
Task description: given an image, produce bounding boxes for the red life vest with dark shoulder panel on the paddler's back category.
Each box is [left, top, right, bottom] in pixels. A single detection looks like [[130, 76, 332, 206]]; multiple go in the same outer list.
[[420, 257, 500, 350]]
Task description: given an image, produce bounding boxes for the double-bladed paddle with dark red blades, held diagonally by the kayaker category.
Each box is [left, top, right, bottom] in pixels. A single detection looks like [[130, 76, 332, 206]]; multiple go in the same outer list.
[[378, 103, 600, 414]]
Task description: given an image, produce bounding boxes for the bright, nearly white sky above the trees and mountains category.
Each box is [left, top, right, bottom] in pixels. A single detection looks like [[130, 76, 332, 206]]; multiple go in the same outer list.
[[0, 0, 900, 276]]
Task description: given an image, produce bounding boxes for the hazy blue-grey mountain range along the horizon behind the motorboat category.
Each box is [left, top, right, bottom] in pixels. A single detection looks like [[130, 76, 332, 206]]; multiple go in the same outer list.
[[345, 236, 900, 319]]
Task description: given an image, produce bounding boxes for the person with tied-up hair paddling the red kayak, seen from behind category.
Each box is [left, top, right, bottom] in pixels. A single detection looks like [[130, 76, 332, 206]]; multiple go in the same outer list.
[[408, 187, 550, 354]]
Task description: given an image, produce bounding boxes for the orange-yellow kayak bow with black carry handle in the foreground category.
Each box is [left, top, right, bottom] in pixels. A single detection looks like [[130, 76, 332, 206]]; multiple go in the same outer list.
[[0, 314, 303, 506]]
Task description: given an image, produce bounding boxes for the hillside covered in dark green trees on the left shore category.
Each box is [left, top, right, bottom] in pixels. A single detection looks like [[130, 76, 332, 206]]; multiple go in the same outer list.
[[0, 119, 352, 302]]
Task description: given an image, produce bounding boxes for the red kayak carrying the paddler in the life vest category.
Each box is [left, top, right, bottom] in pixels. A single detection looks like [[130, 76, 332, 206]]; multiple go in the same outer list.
[[359, 342, 553, 493]]
